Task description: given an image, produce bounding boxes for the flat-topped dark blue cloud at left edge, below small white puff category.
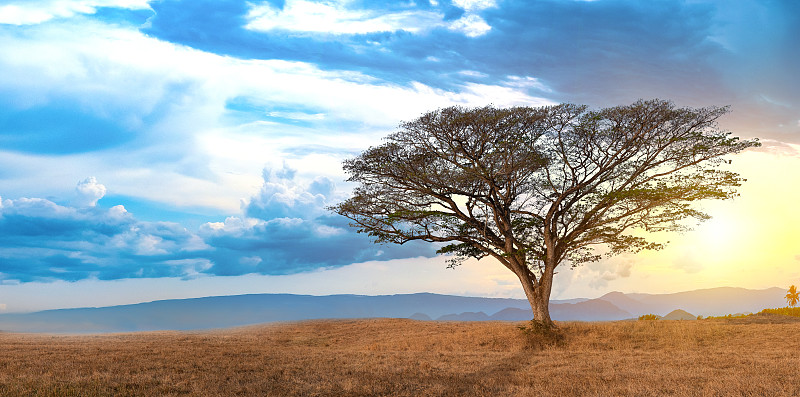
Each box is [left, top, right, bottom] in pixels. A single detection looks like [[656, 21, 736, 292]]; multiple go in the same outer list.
[[0, 198, 203, 282]]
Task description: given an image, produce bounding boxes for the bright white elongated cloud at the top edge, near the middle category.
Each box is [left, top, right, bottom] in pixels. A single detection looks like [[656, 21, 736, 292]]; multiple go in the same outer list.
[[246, 0, 442, 34]]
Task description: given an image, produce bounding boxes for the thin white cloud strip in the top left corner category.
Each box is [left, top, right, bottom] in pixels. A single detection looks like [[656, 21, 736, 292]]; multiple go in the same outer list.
[[0, 0, 150, 25]]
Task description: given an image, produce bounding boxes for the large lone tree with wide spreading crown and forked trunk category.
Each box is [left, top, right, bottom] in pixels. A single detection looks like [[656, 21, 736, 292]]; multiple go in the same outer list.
[[331, 100, 759, 327]]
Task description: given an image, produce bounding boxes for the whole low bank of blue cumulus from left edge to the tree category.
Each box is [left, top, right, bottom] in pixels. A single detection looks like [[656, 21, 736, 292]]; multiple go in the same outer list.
[[0, 170, 435, 283]]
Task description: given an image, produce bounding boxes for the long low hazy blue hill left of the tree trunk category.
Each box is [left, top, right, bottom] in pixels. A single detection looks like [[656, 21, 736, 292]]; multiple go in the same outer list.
[[0, 293, 530, 333]]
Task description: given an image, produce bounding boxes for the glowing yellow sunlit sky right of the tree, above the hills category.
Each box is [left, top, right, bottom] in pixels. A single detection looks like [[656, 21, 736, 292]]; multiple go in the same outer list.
[[557, 145, 800, 297]]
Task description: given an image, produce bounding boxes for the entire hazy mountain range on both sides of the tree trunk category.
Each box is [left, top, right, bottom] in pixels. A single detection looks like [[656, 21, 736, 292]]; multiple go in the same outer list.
[[0, 287, 786, 333]]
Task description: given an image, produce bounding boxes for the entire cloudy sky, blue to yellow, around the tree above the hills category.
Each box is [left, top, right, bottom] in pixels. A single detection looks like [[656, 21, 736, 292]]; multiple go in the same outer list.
[[0, 0, 800, 313]]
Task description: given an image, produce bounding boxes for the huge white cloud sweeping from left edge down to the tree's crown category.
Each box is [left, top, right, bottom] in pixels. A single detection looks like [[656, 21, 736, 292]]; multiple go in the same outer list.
[[0, 16, 552, 213]]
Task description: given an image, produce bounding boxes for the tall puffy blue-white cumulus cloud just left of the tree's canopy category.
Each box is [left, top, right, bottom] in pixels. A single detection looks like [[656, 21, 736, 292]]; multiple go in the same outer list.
[[199, 165, 435, 275]]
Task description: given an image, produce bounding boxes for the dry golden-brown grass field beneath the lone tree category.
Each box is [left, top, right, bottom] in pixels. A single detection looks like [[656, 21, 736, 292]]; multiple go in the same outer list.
[[0, 315, 800, 396]]
